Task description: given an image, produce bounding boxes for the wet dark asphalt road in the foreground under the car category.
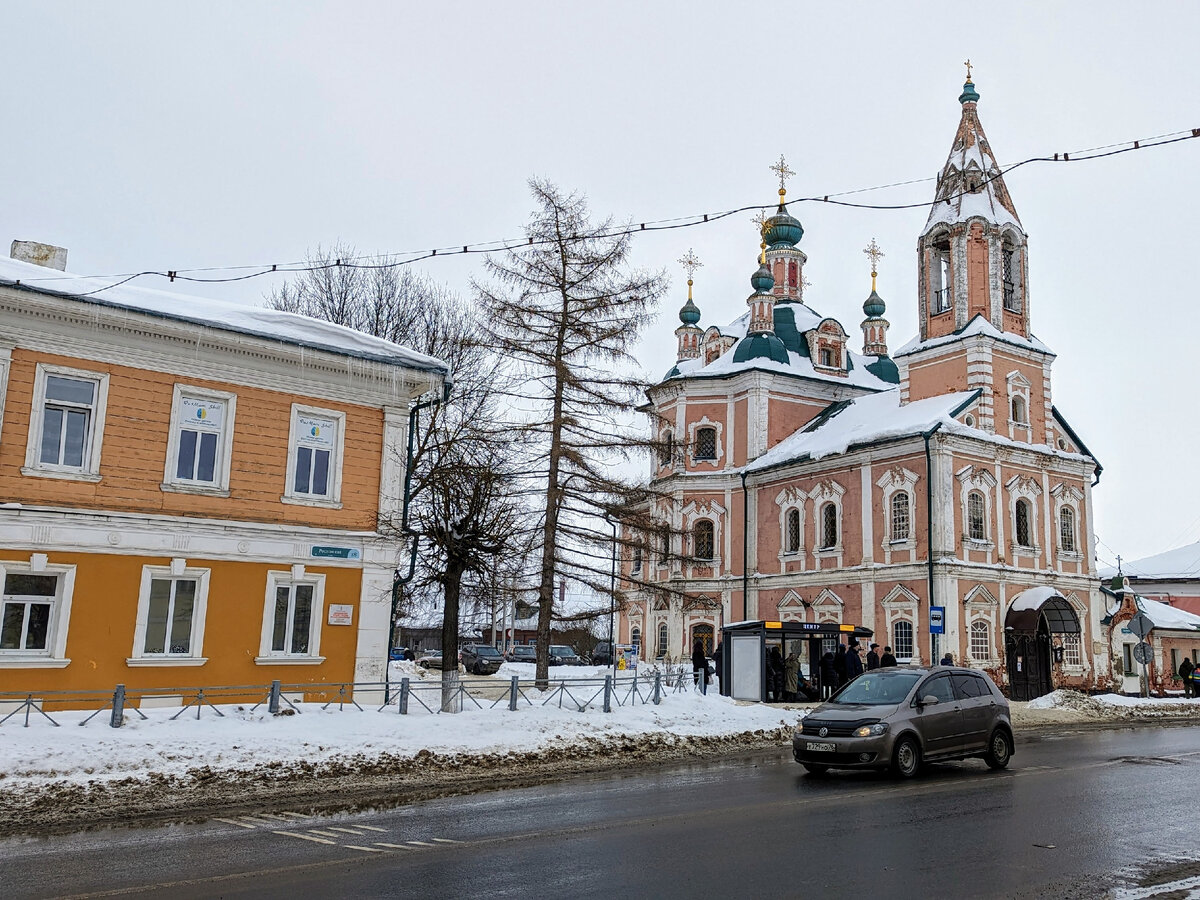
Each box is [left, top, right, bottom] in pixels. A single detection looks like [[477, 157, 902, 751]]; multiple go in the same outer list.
[[0, 727, 1200, 900]]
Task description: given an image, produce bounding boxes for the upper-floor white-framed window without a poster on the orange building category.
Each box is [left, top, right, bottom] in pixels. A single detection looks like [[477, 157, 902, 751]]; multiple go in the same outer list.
[[22, 365, 108, 481]]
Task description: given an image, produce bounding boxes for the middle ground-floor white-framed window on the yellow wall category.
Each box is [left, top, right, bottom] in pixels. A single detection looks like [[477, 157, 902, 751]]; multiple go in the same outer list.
[[127, 559, 209, 665]]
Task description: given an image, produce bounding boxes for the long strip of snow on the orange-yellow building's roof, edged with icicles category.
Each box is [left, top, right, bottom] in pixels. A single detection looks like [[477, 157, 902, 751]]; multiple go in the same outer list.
[[0, 259, 450, 376]]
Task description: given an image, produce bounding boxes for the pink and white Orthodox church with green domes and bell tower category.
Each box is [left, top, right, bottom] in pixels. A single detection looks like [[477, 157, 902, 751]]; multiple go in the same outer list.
[[620, 78, 1111, 698]]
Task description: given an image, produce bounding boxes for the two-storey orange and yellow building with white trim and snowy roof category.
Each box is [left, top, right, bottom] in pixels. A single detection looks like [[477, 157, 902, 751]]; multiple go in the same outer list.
[[0, 244, 448, 692]]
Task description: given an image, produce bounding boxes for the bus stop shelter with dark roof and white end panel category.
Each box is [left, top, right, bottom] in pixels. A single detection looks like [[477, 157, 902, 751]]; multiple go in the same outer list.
[[721, 622, 874, 702]]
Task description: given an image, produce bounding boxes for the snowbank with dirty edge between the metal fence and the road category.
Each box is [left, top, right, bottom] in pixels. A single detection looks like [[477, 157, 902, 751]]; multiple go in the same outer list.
[[0, 686, 804, 792]]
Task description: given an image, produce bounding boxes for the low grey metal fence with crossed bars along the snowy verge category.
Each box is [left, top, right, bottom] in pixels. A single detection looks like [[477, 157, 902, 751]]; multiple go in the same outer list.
[[0, 665, 708, 728]]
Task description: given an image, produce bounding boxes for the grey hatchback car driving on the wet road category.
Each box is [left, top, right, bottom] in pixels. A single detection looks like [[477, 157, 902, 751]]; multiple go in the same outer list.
[[792, 666, 1014, 778]]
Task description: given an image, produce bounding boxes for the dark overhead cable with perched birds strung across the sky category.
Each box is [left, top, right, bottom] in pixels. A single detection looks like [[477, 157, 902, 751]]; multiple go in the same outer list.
[[17, 128, 1200, 296]]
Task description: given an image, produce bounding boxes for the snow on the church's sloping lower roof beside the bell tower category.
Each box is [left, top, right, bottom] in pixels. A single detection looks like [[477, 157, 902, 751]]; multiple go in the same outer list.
[[746, 388, 984, 472]]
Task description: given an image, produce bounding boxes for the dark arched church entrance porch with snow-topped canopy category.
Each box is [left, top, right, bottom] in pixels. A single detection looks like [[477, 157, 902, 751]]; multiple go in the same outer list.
[[1004, 587, 1080, 700]]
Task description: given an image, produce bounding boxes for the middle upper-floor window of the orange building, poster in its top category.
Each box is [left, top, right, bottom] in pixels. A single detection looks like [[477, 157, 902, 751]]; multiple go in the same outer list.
[[163, 384, 238, 492]]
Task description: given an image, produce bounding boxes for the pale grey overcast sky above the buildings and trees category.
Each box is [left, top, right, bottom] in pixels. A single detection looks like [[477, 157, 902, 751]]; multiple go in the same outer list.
[[9, 0, 1200, 562]]
